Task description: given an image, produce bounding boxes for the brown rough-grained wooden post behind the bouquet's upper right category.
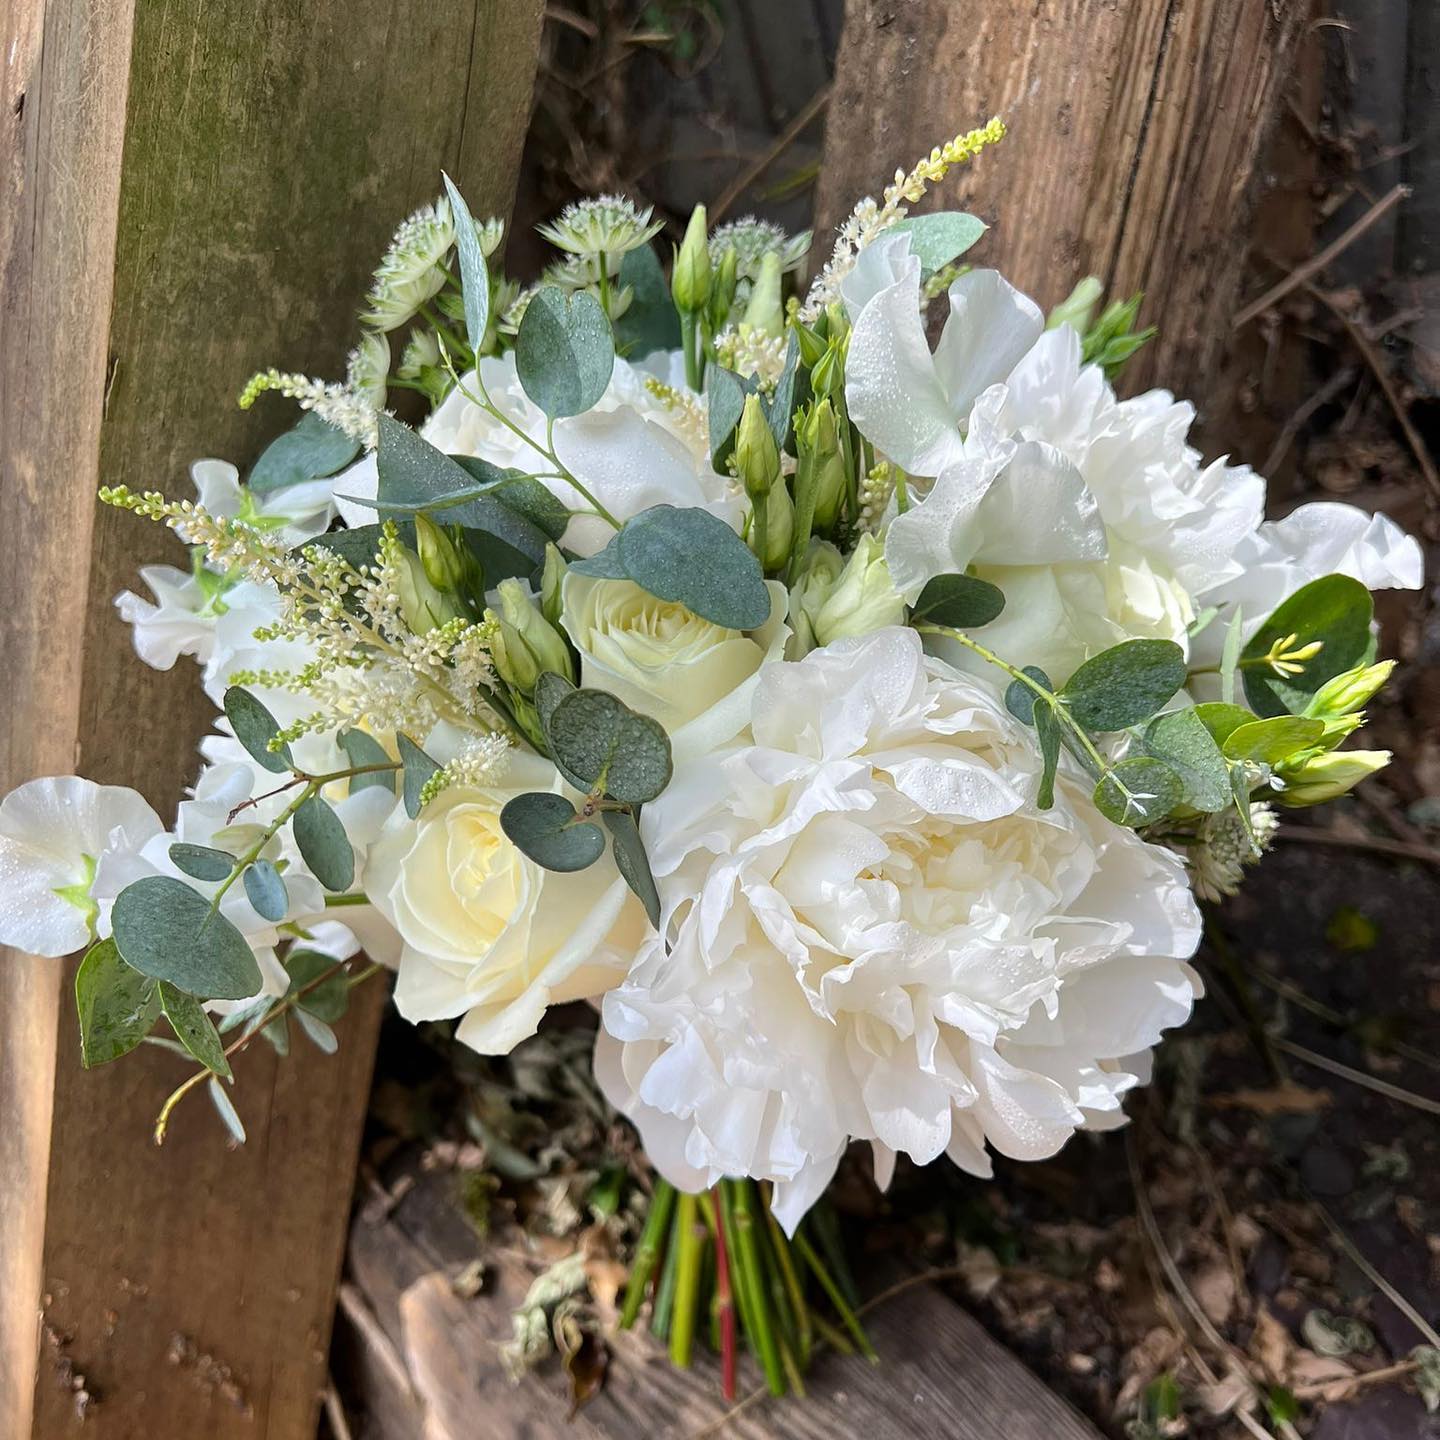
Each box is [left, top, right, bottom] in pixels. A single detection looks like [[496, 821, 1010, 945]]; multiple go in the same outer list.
[[816, 0, 1310, 392]]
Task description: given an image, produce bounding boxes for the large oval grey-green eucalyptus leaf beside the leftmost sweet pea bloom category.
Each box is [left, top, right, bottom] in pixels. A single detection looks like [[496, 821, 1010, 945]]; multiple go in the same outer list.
[[111, 876, 262, 999]]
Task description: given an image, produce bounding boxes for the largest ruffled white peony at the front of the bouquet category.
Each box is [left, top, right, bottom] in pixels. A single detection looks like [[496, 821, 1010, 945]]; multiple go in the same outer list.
[[596, 629, 1200, 1227]]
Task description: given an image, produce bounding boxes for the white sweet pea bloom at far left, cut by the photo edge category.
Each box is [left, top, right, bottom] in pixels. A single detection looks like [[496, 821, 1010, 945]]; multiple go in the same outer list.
[[0, 775, 163, 955]]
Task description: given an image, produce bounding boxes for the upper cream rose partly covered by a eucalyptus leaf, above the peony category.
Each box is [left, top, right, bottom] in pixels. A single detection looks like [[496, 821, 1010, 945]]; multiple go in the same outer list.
[[560, 570, 789, 734]]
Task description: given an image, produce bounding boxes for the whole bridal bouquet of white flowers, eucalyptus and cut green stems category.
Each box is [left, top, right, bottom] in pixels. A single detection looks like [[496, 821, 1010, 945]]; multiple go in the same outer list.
[[0, 121, 1420, 1388]]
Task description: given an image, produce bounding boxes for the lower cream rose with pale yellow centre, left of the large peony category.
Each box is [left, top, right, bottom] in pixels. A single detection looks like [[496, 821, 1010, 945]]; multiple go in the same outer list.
[[364, 753, 648, 1054]]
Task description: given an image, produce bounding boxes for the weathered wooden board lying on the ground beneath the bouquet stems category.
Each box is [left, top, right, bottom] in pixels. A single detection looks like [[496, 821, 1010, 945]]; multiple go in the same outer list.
[[337, 1175, 1099, 1440]]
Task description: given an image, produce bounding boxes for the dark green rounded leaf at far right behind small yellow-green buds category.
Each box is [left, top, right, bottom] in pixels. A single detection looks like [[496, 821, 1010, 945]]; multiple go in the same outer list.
[[1240, 575, 1375, 716]]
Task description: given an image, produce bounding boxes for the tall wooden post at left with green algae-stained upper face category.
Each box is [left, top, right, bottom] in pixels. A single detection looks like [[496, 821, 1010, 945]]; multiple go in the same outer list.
[[0, 0, 541, 1440]]
